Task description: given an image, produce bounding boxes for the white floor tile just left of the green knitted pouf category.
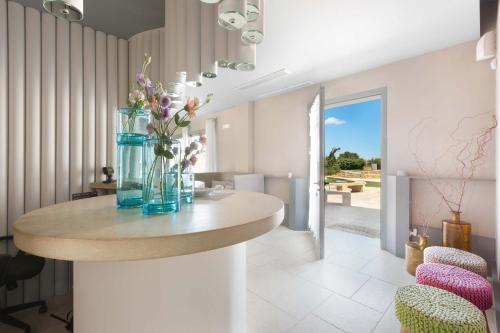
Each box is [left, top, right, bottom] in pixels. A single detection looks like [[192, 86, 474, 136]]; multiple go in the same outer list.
[[352, 278, 398, 313]]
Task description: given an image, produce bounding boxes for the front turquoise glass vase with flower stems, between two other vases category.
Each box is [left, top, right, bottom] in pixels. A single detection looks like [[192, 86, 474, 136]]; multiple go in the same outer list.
[[142, 137, 181, 215]]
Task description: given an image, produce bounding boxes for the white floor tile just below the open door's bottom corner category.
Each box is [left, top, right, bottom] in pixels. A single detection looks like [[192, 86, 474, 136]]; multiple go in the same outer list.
[[297, 260, 370, 297]]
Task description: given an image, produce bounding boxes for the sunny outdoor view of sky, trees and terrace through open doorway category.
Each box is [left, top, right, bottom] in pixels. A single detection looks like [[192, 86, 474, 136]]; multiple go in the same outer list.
[[324, 97, 382, 238]]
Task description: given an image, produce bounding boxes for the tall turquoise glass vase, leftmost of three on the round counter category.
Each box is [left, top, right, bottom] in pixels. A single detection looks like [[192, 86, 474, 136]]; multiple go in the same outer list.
[[116, 108, 150, 208]]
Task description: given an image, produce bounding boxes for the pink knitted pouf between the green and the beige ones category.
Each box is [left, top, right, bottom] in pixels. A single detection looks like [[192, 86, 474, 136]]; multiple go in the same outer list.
[[415, 263, 493, 311]]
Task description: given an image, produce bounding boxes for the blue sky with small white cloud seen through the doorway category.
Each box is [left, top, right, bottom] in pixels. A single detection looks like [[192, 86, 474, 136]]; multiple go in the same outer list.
[[325, 99, 381, 159]]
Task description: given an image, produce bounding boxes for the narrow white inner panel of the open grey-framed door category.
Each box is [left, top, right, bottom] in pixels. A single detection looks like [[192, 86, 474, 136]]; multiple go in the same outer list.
[[308, 95, 321, 240]]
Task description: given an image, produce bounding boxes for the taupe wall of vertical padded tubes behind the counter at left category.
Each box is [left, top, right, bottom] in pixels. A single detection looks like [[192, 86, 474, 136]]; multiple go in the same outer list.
[[0, 0, 129, 305]]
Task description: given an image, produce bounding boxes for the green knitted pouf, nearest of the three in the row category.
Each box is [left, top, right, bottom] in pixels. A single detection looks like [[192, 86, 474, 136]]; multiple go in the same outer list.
[[395, 285, 487, 333]]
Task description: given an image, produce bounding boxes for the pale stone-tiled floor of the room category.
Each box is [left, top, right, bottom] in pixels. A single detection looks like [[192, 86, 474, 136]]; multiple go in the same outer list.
[[0, 227, 496, 333]]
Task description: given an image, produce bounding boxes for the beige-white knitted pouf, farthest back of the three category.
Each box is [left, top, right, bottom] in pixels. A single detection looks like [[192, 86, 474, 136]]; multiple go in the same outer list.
[[424, 246, 488, 277]]
